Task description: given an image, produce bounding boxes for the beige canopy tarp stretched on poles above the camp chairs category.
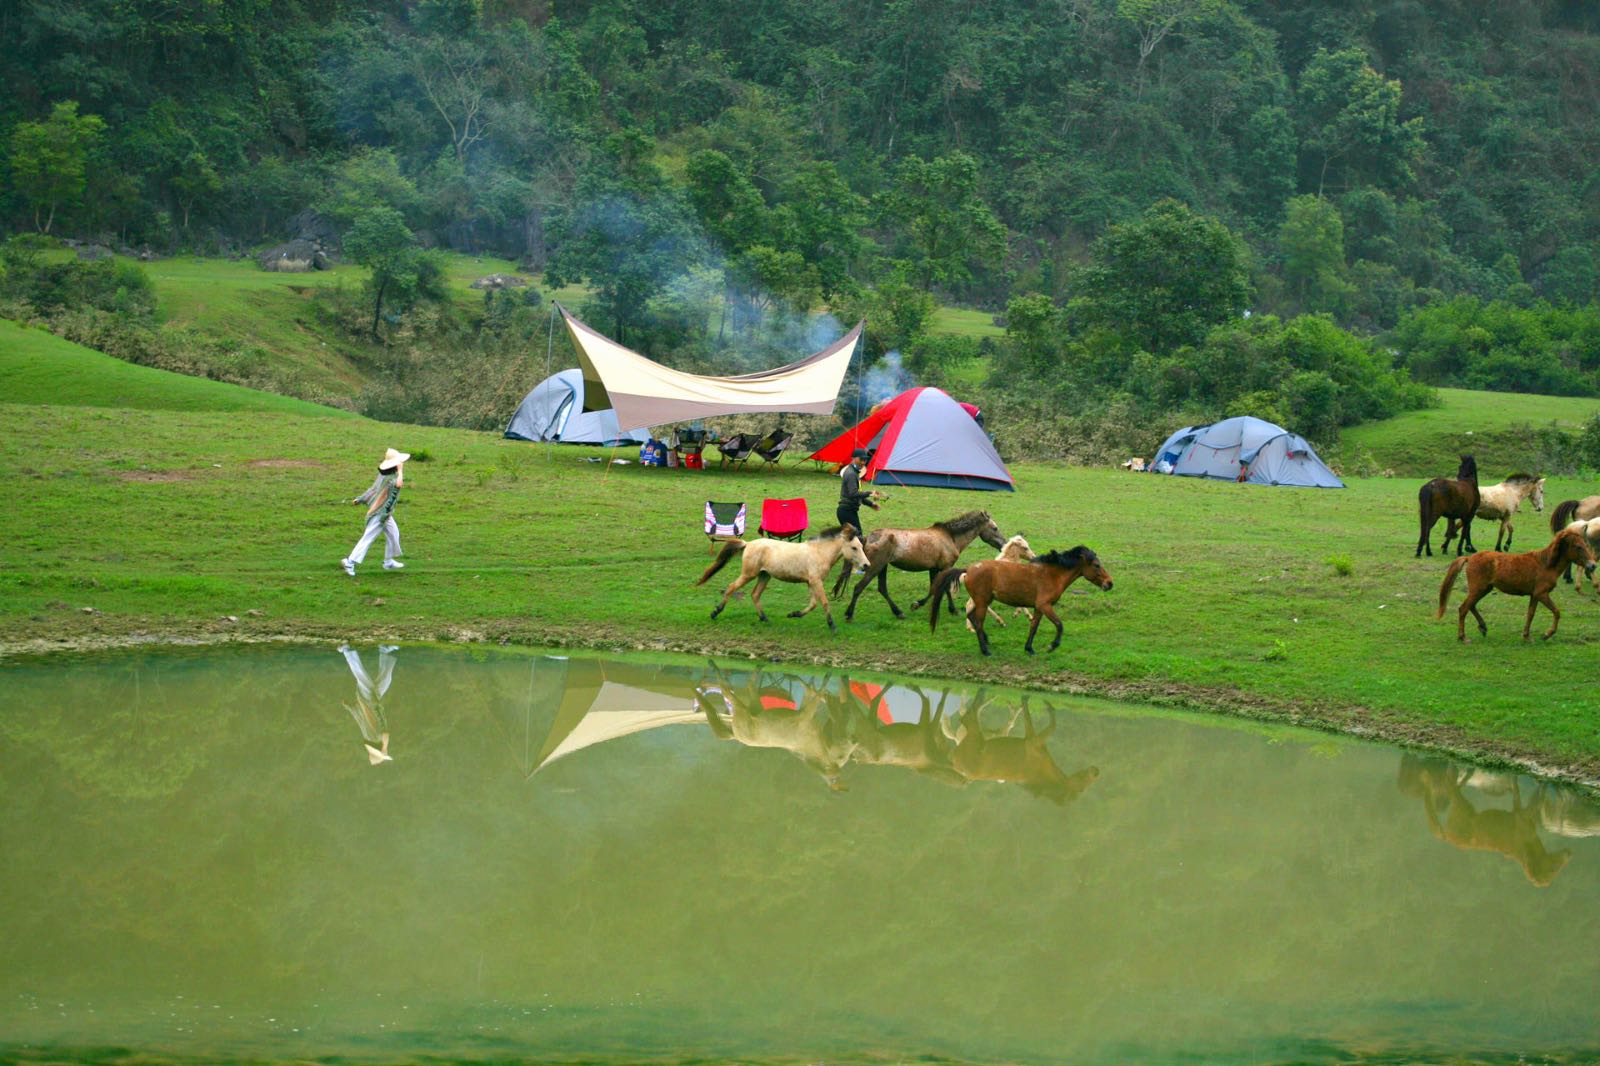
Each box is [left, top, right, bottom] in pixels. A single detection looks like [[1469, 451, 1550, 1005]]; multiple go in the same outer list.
[[562, 300, 866, 426]]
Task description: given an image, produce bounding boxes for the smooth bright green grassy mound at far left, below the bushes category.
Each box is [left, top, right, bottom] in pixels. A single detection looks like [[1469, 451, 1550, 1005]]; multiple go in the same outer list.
[[0, 319, 352, 418]]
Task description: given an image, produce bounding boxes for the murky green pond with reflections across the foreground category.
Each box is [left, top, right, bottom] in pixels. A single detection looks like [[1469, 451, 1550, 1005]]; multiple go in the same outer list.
[[0, 647, 1600, 1063]]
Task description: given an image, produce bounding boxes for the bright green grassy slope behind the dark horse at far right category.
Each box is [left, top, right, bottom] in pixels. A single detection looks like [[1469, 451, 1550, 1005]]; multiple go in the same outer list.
[[1334, 389, 1600, 482]]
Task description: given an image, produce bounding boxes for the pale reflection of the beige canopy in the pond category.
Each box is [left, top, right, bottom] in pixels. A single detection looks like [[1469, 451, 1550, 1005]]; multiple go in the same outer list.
[[531, 661, 706, 773]]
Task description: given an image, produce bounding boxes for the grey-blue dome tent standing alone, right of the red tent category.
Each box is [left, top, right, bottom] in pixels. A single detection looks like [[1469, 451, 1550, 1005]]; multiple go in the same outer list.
[[1154, 415, 1344, 488]]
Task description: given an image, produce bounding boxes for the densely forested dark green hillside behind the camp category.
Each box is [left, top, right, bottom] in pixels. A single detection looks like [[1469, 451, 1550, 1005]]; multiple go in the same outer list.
[[0, 0, 1600, 457]]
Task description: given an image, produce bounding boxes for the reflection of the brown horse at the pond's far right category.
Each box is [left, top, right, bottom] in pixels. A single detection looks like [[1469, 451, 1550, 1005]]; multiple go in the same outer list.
[[1400, 754, 1573, 888]]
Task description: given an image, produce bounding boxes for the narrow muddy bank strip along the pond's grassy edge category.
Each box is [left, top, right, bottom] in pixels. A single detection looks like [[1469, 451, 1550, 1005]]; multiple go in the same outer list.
[[0, 613, 1600, 792]]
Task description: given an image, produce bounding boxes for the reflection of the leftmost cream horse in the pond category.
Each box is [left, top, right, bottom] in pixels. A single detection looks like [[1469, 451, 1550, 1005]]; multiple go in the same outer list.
[[696, 674, 856, 791]]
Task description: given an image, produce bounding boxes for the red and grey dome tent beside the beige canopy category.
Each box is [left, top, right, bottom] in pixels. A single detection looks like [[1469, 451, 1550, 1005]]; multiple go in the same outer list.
[[811, 389, 1013, 491]]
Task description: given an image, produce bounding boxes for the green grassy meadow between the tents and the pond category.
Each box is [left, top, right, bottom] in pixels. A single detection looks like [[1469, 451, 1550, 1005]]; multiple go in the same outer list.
[[9, 320, 1600, 783]]
